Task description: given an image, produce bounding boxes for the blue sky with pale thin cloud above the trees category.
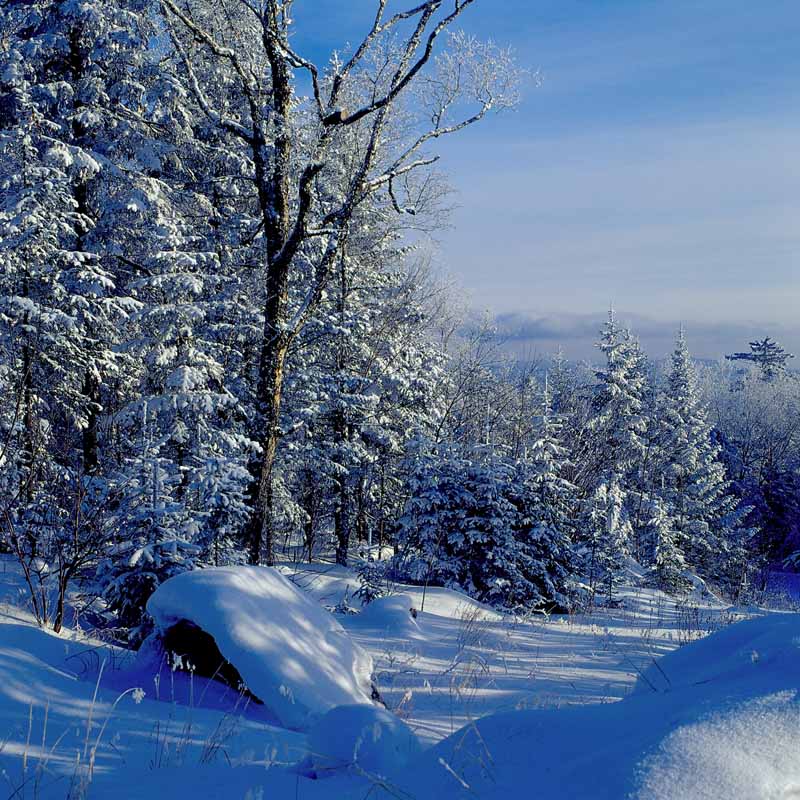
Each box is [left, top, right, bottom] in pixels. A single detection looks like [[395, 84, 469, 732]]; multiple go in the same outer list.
[[295, 0, 800, 357]]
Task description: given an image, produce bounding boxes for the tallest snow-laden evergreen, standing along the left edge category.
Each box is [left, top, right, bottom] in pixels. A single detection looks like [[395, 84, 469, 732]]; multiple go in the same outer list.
[[0, 0, 159, 627]]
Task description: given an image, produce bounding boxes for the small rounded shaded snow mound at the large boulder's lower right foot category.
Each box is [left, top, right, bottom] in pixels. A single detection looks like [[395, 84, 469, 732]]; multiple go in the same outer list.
[[308, 705, 421, 776]]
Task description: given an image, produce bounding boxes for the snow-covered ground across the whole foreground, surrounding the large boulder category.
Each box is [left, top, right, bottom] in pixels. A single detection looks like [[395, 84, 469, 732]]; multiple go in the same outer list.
[[0, 561, 800, 800]]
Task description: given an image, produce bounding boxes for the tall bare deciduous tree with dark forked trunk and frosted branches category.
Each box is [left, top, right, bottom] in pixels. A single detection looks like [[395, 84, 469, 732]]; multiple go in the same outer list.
[[160, 0, 518, 563]]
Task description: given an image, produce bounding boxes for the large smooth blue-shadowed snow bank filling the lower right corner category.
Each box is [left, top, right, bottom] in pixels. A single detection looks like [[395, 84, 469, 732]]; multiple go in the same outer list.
[[382, 614, 800, 800]]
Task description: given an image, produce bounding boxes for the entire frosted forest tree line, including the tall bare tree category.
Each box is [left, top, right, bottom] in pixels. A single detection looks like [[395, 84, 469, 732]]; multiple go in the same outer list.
[[0, 0, 800, 638]]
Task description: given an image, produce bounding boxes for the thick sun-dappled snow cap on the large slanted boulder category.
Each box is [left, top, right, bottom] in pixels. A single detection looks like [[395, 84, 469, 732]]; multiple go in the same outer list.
[[147, 567, 372, 730]]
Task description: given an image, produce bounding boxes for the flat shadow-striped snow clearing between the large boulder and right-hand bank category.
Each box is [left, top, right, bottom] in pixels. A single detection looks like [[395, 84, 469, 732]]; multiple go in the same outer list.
[[284, 564, 739, 743]]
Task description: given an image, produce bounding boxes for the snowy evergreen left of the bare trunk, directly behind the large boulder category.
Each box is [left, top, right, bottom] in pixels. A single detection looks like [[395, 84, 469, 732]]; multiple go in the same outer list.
[[99, 167, 255, 624]]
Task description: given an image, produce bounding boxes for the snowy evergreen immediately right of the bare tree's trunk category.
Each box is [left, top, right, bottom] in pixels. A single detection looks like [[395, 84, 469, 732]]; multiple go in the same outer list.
[[278, 213, 443, 563]]
